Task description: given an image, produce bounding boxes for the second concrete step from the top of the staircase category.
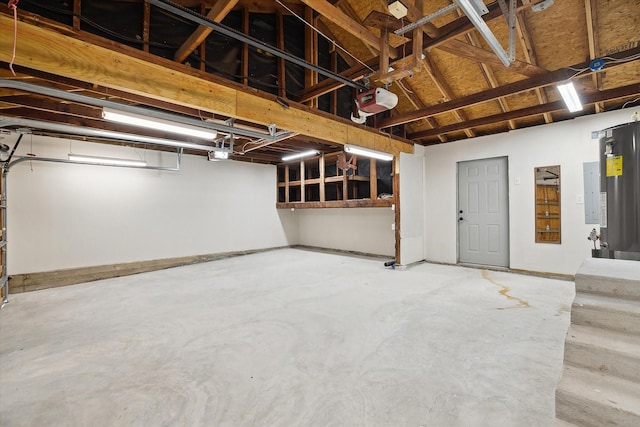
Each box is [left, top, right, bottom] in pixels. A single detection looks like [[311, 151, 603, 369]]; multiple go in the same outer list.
[[571, 293, 640, 336]]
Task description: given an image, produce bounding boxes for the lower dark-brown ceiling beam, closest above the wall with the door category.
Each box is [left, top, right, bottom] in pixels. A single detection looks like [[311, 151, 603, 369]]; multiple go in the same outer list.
[[407, 83, 640, 140]]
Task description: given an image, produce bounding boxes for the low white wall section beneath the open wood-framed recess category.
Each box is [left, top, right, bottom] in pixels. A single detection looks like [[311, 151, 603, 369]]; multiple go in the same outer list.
[[292, 208, 395, 257]]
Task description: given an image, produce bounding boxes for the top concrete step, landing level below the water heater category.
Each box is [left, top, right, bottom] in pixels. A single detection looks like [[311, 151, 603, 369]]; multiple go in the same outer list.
[[575, 258, 640, 301]]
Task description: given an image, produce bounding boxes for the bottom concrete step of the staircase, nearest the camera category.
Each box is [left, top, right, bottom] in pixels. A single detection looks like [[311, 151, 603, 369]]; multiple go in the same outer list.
[[556, 365, 640, 427]]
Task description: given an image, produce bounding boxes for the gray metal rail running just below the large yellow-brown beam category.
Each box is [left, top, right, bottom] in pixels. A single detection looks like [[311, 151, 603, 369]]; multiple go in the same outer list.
[[0, 79, 271, 140]]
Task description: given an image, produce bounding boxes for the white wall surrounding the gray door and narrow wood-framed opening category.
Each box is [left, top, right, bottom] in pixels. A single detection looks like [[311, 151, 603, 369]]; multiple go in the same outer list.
[[425, 109, 633, 275]]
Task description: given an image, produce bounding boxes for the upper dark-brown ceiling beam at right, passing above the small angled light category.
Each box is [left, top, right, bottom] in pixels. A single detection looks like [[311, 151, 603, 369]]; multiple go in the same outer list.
[[378, 46, 640, 128]]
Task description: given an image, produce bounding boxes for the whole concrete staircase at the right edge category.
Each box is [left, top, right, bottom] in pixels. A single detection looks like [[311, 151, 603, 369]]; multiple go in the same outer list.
[[556, 258, 640, 427]]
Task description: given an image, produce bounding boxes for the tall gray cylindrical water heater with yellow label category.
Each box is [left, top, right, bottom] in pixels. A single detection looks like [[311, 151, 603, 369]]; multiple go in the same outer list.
[[594, 122, 640, 261]]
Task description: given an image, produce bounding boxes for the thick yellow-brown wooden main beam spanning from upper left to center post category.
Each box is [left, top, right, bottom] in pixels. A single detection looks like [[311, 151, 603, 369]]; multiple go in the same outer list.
[[0, 14, 413, 154]]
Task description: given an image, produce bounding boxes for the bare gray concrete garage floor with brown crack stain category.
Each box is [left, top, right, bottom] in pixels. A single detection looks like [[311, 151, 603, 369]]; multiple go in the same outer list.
[[0, 249, 574, 427]]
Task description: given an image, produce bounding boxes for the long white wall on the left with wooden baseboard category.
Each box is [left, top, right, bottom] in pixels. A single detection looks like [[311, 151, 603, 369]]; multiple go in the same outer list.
[[3, 135, 298, 274]]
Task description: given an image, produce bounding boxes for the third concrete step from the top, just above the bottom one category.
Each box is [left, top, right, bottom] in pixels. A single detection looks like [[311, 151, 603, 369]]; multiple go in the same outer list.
[[564, 325, 640, 382]]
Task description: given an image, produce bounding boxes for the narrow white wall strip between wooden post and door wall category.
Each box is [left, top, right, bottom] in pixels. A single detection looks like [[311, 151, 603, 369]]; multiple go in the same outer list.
[[399, 146, 424, 265]]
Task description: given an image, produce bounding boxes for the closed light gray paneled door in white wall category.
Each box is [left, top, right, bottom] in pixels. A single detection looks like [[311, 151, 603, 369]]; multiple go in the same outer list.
[[458, 157, 509, 267]]
